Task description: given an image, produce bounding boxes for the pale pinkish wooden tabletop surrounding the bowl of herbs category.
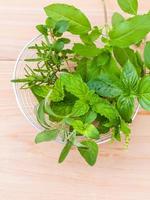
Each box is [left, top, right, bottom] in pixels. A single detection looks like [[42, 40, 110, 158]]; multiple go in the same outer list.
[[0, 0, 150, 200]]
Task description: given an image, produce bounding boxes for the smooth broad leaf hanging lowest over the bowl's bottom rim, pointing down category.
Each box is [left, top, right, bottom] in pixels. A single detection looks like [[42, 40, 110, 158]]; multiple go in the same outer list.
[[78, 141, 98, 166]]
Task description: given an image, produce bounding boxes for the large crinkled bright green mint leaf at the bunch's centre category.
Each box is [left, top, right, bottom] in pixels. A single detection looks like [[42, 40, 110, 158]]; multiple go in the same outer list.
[[61, 73, 89, 99]]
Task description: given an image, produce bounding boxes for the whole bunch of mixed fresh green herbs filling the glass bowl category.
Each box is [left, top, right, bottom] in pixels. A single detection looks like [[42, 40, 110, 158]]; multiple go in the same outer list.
[[13, 0, 150, 165]]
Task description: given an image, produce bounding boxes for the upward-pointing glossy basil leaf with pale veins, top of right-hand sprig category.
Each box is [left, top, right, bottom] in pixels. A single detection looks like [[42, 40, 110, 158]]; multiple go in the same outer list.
[[121, 61, 139, 94]]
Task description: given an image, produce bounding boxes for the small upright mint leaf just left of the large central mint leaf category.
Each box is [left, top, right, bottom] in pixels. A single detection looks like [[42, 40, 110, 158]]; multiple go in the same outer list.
[[50, 79, 64, 102]]
